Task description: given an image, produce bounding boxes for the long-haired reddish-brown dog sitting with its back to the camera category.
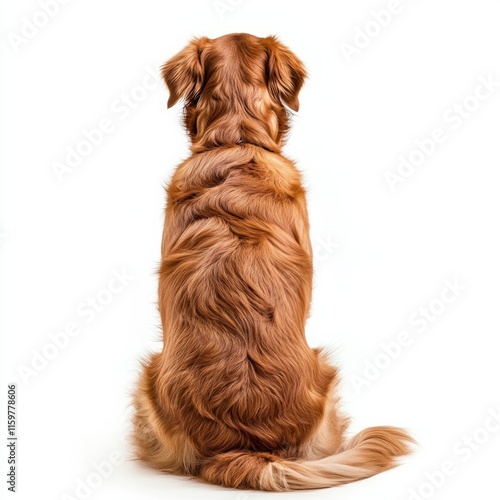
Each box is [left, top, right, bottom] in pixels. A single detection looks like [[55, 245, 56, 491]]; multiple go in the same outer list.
[[133, 34, 413, 491]]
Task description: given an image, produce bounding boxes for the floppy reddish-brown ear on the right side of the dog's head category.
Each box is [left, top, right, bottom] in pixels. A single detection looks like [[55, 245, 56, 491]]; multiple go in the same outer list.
[[264, 36, 307, 111]]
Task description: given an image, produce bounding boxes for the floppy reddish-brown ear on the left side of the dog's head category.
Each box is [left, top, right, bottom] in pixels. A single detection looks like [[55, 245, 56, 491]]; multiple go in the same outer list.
[[161, 37, 209, 108]]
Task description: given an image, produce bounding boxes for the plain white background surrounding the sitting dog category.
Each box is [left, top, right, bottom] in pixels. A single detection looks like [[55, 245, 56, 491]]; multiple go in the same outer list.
[[0, 0, 500, 500]]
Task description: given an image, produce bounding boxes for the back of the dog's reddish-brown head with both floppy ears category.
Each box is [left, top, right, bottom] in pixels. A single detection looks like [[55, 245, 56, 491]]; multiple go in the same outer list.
[[162, 34, 306, 150]]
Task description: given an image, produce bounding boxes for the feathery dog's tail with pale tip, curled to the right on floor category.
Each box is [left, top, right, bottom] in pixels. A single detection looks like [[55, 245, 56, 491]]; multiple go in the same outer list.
[[199, 427, 415, 491]]
